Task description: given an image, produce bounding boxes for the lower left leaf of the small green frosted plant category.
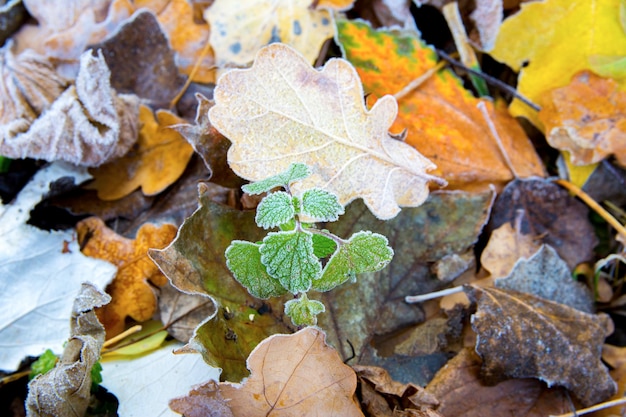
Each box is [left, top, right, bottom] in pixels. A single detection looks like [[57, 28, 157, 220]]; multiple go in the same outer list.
[[226, 240, 286, 299]]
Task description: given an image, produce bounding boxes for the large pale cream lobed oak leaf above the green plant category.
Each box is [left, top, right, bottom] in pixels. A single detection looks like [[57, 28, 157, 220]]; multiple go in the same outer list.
[[209, 44, 443, 219]]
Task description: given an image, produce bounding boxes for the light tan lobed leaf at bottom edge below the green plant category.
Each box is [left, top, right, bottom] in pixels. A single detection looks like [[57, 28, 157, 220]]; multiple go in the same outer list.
[[170, 327, 363, 417]]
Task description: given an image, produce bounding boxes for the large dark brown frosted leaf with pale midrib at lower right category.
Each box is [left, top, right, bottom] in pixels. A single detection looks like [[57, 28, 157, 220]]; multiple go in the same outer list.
[[466, 286, 617, 406]]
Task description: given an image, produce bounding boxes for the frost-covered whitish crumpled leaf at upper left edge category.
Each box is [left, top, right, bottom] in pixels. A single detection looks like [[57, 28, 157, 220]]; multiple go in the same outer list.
[[0, 50, 139, 166]]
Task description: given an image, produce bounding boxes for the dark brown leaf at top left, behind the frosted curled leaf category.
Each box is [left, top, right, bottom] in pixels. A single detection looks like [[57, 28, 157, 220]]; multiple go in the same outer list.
[[91, 10, 184, 108]]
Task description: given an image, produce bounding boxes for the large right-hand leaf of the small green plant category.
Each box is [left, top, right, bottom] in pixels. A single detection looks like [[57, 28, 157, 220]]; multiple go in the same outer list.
[[313, 231, 393, 291]]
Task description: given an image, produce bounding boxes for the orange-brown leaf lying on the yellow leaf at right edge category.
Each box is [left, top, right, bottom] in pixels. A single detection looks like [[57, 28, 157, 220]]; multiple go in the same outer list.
[[539, 71, 626, 167]]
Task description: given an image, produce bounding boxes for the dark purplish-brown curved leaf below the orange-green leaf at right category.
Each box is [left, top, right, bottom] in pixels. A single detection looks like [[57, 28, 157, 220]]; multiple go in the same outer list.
[[488, 178, 597, 269]]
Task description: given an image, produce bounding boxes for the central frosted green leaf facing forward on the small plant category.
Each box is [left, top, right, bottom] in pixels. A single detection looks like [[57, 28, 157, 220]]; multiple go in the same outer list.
[[259, 231, 322, 294]]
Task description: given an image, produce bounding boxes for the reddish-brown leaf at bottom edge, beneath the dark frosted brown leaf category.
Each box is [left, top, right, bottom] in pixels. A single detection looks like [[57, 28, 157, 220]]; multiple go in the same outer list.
[[426, 348, 571, 417]]
